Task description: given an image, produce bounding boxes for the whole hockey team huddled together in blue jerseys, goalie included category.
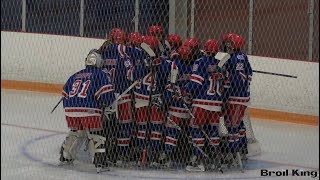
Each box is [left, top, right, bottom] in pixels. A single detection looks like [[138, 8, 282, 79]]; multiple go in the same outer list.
[[60, 26, 252, 172]]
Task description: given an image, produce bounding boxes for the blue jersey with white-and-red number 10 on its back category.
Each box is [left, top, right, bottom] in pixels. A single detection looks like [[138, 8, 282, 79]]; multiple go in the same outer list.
[[185, 56, 226, 111]]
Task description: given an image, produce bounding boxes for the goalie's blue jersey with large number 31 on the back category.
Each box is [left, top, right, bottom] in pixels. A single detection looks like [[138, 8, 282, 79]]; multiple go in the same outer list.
[[62, 67, 115, 117]]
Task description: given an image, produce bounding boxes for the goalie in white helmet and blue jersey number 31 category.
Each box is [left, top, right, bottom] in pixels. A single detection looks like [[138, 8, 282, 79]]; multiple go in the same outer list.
[[60, 50, 115, 172]]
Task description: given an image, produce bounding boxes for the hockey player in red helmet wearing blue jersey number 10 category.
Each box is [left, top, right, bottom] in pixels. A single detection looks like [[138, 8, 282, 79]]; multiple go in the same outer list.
[[185, 39, 223, 171]]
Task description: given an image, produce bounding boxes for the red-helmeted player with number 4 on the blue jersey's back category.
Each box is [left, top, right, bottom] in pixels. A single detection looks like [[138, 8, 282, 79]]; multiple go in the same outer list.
[[133, 36, 171, 164]]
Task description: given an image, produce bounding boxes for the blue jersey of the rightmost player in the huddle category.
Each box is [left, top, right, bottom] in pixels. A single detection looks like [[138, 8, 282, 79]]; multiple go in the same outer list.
[[224, 53, 252, 105]]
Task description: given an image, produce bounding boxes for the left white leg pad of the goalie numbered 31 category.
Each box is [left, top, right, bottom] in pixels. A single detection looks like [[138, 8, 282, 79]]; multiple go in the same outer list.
[[62, 130, 86, 160]]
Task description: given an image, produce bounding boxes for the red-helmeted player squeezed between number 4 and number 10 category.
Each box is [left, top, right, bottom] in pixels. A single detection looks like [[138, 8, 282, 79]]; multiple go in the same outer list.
[[158, 40, 199, 167]]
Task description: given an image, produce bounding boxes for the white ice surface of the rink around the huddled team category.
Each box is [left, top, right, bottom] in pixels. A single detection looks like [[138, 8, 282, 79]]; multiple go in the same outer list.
[[1, 90, 319, 180]]
